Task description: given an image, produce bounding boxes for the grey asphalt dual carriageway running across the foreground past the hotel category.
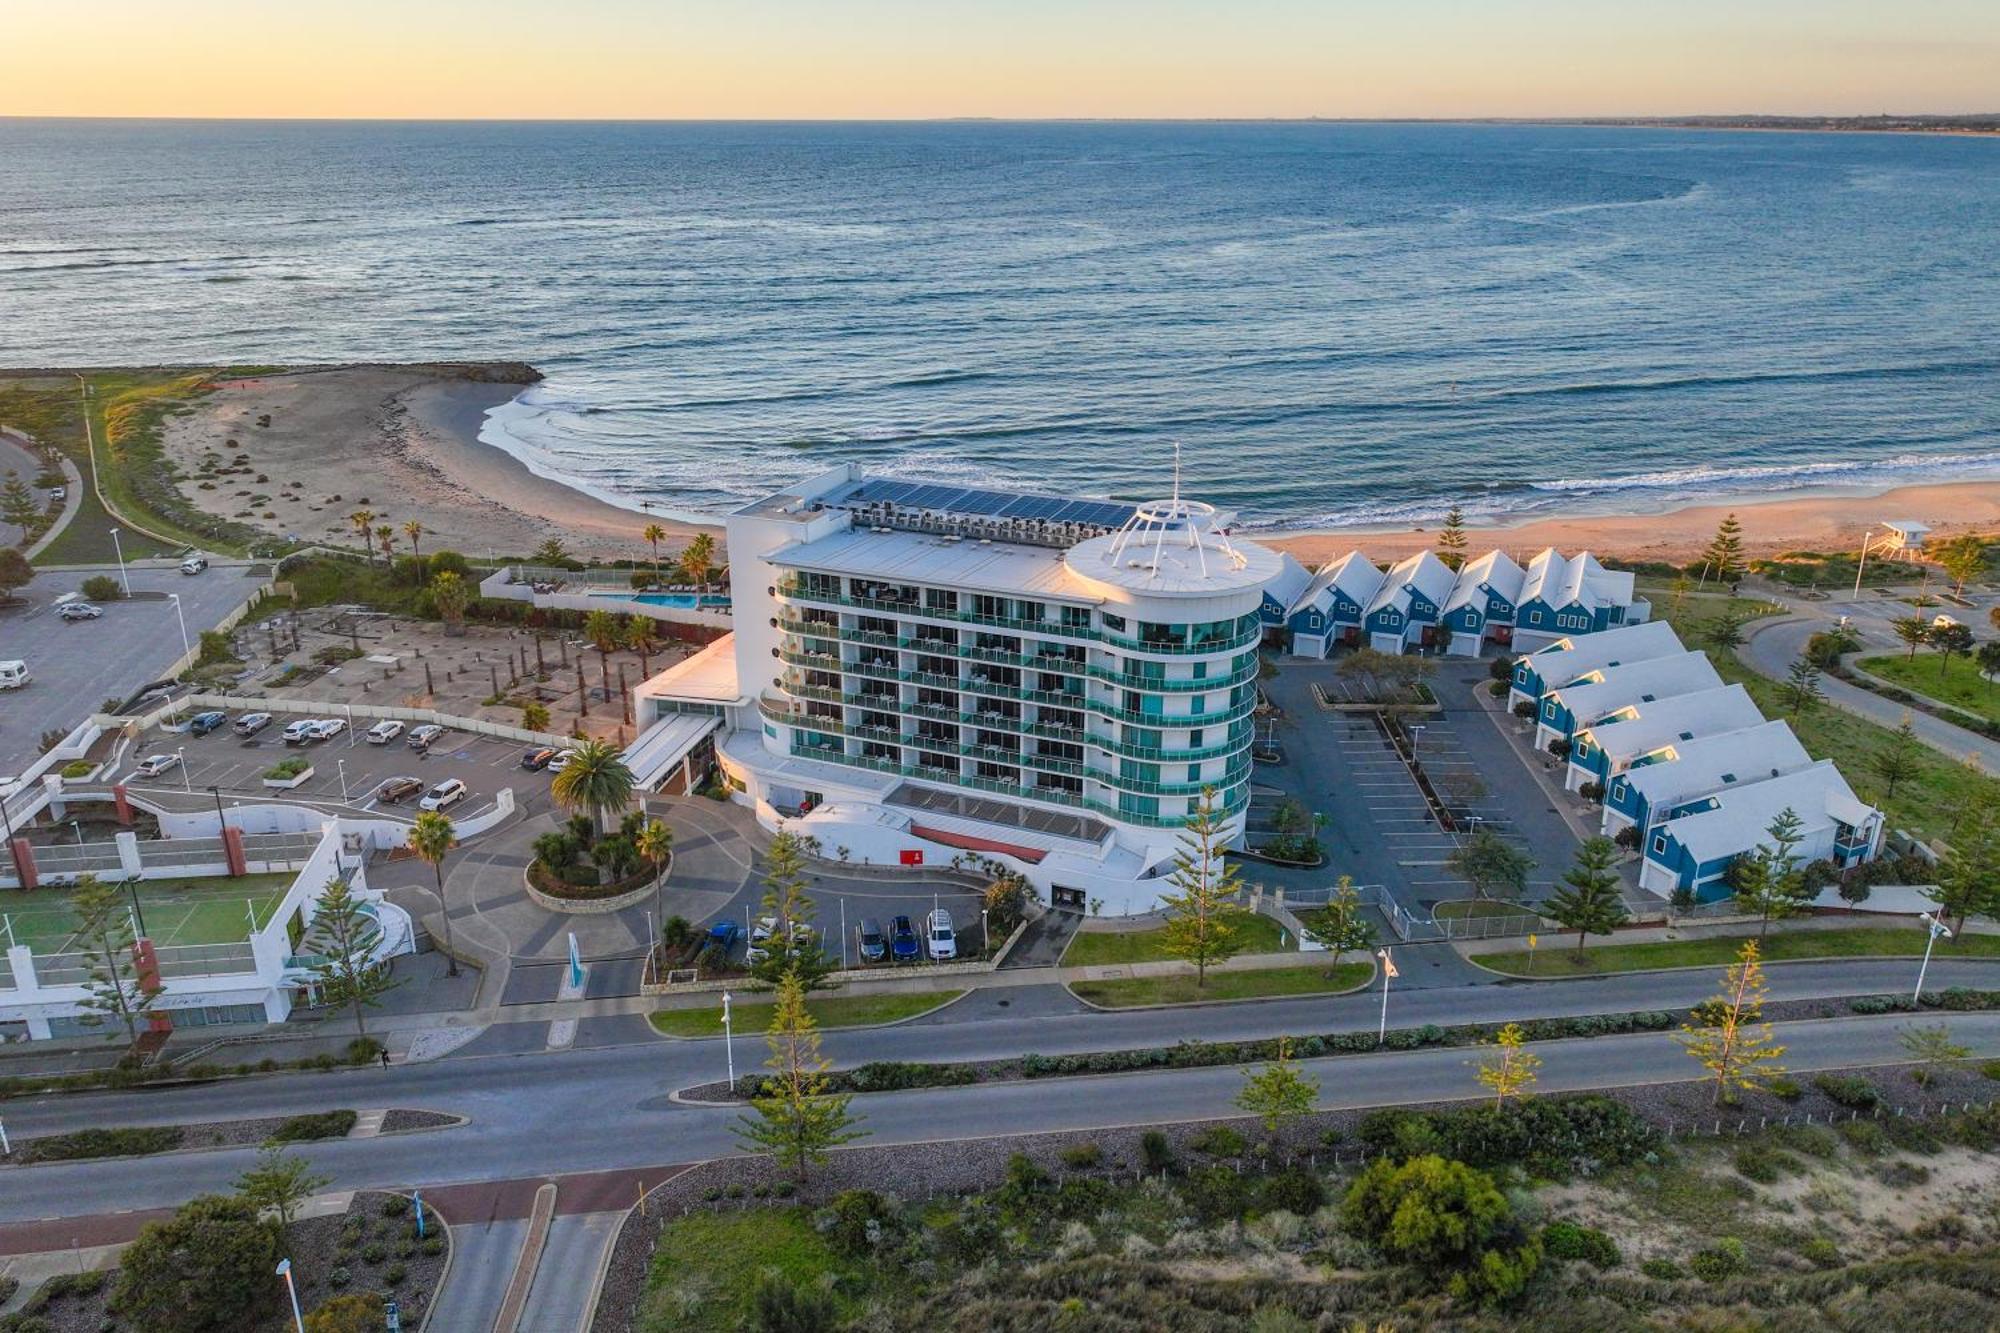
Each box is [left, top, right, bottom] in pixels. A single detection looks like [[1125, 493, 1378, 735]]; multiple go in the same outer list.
[[0, 961, 2000, 1221]]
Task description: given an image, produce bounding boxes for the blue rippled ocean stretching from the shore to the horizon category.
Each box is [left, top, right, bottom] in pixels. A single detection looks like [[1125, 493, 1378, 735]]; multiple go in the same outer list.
[[0, 120, 2000, 526]]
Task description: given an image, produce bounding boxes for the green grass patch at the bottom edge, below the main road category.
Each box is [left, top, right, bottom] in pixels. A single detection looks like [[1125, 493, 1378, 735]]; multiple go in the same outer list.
[[636, 1207, 868, 1333]]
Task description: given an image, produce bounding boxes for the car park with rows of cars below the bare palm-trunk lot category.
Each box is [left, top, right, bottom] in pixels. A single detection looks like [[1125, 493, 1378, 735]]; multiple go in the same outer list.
[[108, 711, 532, 819]]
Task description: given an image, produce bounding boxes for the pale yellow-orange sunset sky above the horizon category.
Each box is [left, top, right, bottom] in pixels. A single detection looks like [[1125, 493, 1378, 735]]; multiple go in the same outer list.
[[0, 0, 2000, 120]]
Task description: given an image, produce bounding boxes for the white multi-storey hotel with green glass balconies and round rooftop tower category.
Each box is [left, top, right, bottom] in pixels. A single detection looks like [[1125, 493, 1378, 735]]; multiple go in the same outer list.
[[642, 464, 1280, 911]]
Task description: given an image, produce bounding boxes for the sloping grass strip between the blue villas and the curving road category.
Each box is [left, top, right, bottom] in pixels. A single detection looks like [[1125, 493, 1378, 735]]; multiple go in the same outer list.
[[1646, 572, 2000, 839]]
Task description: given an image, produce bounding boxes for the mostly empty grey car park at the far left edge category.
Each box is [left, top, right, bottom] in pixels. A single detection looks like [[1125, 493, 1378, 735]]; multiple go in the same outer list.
[[0, 564, 264, 775]]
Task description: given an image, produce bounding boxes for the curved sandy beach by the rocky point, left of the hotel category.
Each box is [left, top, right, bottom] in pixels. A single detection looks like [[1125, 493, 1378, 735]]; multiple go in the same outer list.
[[164, 366, 712, 560]]
